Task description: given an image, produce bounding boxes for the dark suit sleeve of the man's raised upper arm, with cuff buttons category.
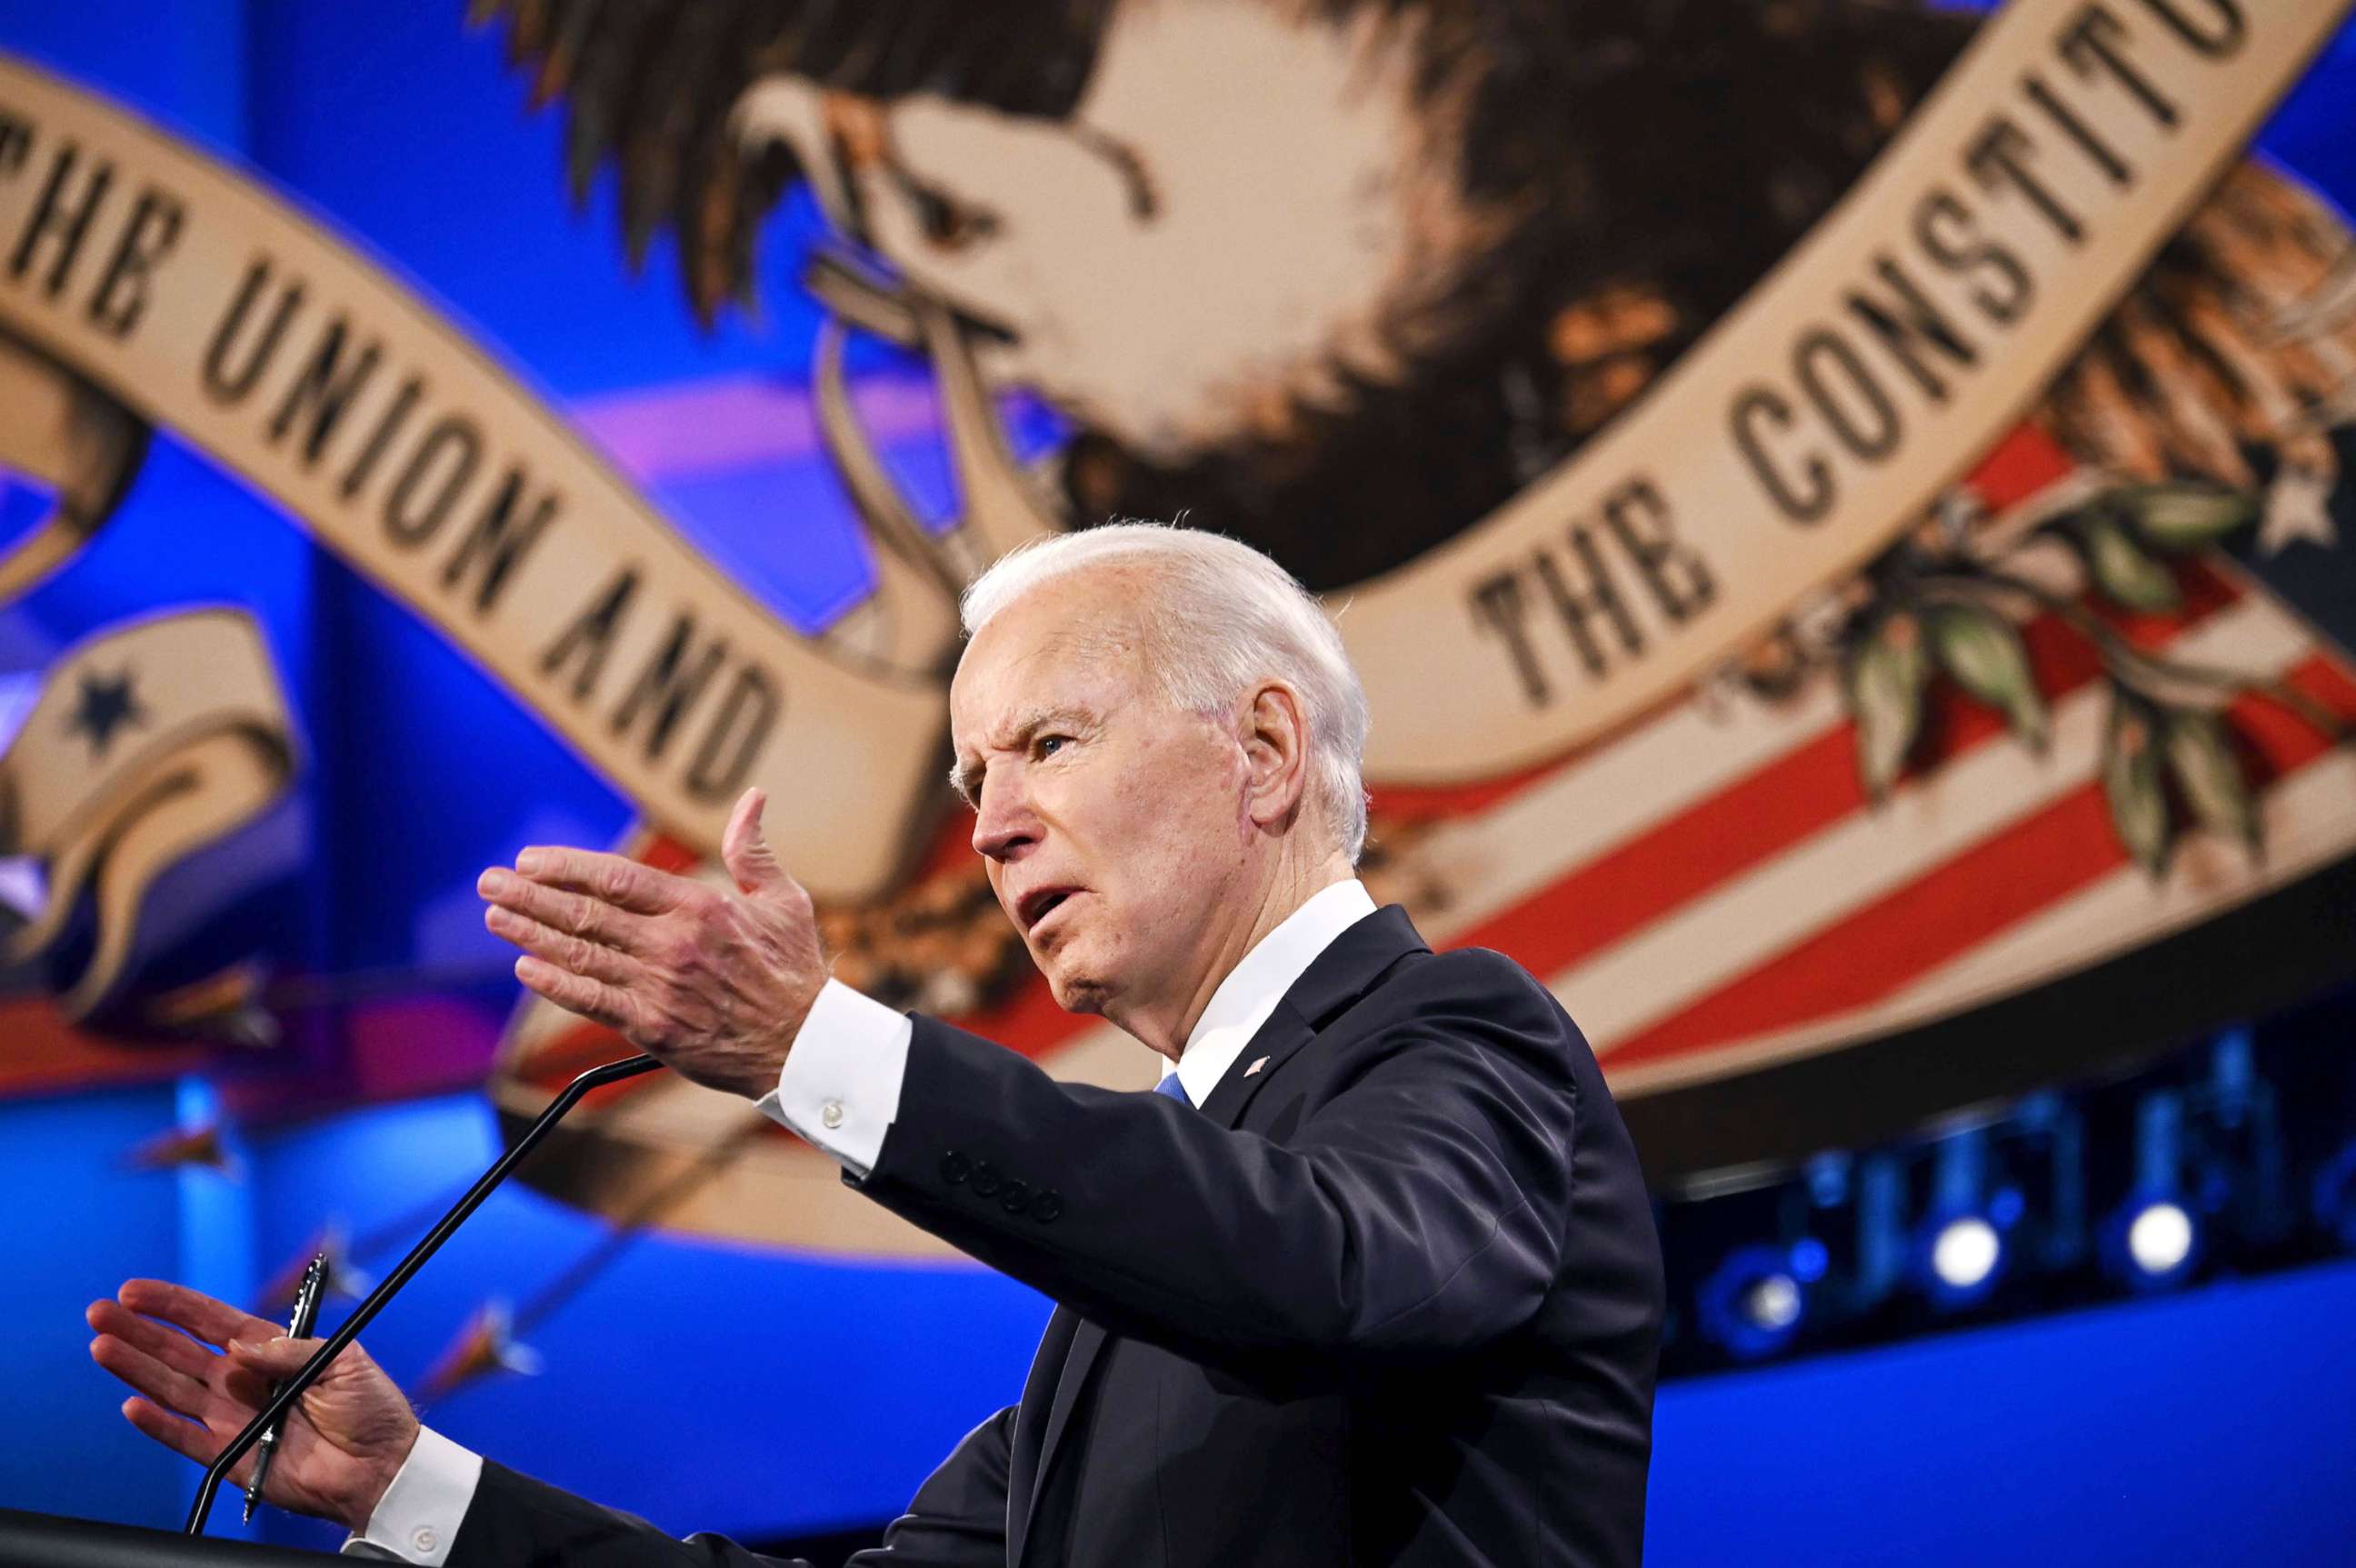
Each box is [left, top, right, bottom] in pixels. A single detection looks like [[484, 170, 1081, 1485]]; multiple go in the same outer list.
[[860, 951, 1585, 1373]]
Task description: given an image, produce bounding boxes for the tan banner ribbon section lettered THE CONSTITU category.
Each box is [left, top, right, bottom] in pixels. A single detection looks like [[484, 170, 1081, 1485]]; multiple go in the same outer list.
[[1341, 0, 2349, 782]]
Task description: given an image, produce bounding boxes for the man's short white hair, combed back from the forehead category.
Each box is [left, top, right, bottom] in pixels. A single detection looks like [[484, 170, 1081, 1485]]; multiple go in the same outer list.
[[959, 523, 1366, 866]]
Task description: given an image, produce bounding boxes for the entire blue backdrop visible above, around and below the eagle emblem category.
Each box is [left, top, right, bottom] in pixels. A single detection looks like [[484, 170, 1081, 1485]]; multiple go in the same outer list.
[[0, 0, 2356, 1563]]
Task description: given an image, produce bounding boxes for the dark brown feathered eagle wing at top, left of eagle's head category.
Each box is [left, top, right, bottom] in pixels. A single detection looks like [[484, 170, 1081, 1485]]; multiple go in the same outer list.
[[469, 0, 1114, 325]]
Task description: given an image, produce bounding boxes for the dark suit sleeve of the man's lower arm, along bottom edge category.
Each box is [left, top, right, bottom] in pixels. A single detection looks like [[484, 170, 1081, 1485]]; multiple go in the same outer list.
[[450, 1408, 1015, 1568]]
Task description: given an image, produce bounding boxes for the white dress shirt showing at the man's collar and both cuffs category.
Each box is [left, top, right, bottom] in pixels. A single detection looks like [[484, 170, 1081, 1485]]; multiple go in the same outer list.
[[344, 878, 1373, 1568]]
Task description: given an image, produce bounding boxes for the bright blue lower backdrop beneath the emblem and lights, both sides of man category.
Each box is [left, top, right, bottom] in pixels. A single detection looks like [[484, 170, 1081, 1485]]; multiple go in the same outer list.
[[0, 1088, 2356, 1568]]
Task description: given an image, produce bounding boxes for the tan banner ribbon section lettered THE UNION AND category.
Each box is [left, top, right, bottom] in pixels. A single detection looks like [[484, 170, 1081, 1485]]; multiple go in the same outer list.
[[0, 59, 944, 897]]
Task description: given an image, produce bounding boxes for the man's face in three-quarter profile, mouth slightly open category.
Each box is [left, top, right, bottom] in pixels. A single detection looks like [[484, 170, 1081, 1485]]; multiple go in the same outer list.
[[950, 567, 1256, 1022]]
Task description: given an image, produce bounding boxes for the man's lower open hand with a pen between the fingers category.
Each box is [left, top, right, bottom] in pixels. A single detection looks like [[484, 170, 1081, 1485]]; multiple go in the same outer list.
[[85, 1278, 417, 1531]]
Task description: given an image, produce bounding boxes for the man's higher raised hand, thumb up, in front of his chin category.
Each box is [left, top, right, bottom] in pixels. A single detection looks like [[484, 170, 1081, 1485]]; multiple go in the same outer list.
[[476, 789, 827, 1100]]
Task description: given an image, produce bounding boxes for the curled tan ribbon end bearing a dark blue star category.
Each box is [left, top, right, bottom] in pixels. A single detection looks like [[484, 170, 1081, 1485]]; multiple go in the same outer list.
[[0, 597, 294, 1020]]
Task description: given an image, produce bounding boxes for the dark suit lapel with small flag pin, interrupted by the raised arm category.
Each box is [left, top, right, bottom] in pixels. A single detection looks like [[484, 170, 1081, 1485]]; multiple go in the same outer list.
[[1006, 904, 1430, 1565]]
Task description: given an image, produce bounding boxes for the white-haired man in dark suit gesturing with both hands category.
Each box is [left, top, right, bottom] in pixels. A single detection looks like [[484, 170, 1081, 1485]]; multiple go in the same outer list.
[[92, 525, 1661, 1568]]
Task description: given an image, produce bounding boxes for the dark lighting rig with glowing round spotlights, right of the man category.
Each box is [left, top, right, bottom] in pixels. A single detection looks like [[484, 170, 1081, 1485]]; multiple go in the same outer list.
[[1656, 986, 2356, 1377]]
